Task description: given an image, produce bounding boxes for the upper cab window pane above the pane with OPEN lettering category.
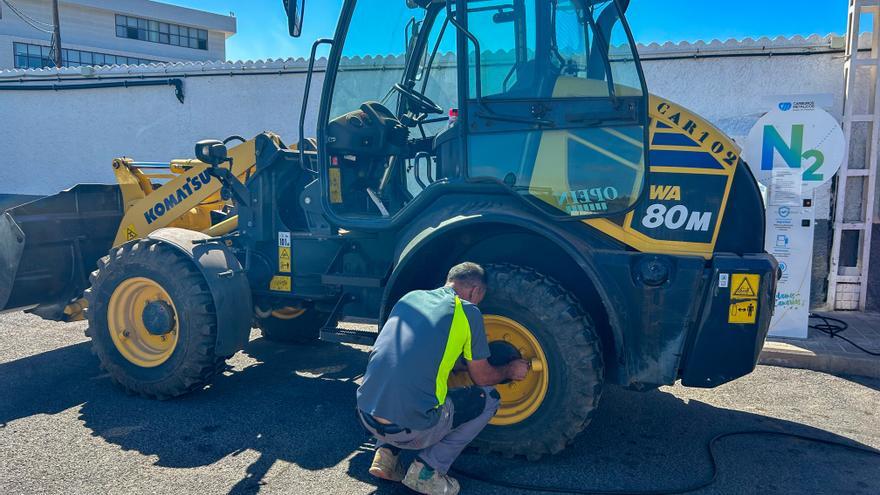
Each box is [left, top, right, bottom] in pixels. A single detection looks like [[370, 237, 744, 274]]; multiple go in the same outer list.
[[468, 0, 642, 99]]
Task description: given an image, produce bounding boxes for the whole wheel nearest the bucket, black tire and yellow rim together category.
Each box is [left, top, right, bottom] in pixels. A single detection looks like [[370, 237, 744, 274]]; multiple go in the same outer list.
[[85, 239, 225, 399]]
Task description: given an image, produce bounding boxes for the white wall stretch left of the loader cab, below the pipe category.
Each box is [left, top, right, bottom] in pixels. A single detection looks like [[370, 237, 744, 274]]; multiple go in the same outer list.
[[0, 65, 321, 195]]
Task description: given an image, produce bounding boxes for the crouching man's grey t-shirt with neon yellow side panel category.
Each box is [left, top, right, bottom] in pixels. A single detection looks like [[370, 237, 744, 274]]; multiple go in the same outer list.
[[357, 287, 490, 431]]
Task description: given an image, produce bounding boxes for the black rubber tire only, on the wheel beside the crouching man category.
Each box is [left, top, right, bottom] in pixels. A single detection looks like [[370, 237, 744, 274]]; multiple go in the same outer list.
[[473, 265, 604, 460]]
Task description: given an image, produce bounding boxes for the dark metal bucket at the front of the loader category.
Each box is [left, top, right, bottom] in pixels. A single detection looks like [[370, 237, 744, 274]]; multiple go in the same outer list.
[[0, 184, 124, 321]]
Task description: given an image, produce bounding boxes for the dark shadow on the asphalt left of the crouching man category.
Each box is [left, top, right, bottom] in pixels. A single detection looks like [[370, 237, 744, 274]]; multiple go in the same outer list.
[[0, 339, 367, 493]]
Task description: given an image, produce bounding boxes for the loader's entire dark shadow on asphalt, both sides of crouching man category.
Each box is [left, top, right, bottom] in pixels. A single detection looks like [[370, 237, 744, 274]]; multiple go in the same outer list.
[[0, 339, 880, 494]]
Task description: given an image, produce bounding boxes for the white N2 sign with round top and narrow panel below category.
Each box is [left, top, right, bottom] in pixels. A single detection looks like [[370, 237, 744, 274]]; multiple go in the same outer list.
[[743, 96, 846, 338]]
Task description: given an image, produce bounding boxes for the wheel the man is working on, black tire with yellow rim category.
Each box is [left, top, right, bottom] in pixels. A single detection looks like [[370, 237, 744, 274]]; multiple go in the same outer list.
[[474, 265, 604, 460]]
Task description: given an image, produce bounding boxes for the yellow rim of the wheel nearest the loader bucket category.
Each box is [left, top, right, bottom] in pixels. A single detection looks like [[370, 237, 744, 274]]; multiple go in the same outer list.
[[107, 277, 180, 368]]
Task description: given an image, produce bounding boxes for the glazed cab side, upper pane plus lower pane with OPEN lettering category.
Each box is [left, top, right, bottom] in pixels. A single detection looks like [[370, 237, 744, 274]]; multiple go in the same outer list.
[[464, 0, 647, 220]]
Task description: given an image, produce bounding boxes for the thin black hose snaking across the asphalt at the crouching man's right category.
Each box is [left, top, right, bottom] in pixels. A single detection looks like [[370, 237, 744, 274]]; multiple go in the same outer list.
[[450, 430, 880, 495]]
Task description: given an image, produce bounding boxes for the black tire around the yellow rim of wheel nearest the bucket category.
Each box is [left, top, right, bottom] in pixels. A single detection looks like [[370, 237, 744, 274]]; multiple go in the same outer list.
[[85, 239, 226, 400]]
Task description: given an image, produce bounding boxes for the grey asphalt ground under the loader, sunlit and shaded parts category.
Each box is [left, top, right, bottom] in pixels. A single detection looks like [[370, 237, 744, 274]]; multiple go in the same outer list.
[[0, 313, 880, 495]]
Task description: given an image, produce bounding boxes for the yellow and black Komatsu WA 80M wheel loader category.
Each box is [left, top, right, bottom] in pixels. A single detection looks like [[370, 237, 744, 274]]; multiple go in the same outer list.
[[0, 0, 778, 457]]
